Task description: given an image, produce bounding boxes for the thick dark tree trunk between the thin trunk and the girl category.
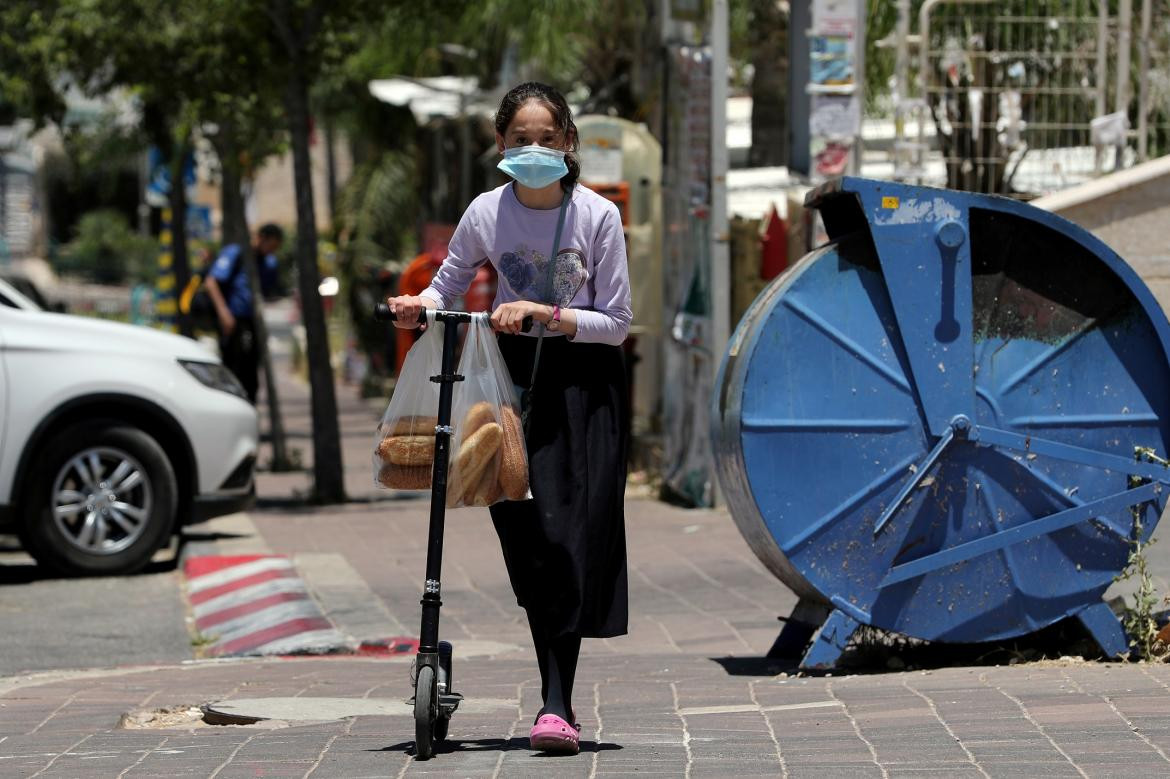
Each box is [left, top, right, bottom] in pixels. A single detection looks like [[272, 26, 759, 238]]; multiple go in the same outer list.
[[285, 68, 345, 503]]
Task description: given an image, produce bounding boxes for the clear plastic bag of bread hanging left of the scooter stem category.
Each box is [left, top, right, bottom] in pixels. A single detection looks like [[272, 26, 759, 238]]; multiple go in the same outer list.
[[373, 316, 446, 490]]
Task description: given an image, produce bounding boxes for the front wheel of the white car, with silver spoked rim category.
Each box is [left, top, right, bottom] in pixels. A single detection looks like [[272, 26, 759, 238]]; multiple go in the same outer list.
[[21, 422, 178, 574]]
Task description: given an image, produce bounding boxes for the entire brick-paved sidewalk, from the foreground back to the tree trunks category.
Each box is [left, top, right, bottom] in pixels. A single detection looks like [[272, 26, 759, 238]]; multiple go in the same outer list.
[[0, 360, 1170, 779]]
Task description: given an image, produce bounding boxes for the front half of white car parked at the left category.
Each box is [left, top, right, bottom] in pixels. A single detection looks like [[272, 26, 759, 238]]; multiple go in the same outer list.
[[0, 281, 259, 574]]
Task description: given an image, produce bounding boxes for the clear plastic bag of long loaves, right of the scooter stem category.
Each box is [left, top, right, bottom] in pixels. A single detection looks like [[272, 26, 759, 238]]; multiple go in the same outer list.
[[447, 313, 531, 508]]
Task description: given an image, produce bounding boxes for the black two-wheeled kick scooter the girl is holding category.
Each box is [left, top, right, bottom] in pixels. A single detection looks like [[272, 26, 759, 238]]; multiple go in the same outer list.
[[373, 303, 532, 760]]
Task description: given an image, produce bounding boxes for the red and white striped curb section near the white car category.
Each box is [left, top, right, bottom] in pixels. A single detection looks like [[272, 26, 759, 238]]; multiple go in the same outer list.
[[184, 554, 355, 657]]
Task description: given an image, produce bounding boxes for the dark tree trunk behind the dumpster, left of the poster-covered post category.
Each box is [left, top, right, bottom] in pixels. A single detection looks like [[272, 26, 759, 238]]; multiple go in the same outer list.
[[748, 0, 789, 167]]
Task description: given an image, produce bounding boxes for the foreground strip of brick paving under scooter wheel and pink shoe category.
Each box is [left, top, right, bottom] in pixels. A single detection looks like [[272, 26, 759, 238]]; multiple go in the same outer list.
[[0, 631, 1170, 778]]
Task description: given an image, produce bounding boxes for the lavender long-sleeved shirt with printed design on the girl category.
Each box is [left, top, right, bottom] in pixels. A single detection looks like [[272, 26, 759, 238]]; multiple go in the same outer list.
[[421, 184, 633, 344]]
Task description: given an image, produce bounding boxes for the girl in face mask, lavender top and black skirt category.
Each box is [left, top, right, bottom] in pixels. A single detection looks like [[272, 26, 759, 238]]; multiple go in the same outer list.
[[387, 83, 632, 754]]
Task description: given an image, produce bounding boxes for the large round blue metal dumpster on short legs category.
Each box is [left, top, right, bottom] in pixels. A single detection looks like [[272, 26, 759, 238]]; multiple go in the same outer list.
[[713, 178, 1170, 668]]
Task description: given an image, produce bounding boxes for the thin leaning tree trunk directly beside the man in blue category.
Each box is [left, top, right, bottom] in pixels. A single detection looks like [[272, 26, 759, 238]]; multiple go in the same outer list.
[[215, 136, 293, 473]]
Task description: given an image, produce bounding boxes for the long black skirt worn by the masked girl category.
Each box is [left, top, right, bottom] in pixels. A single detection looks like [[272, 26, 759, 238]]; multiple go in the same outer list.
[[491, 336, 629, 639]]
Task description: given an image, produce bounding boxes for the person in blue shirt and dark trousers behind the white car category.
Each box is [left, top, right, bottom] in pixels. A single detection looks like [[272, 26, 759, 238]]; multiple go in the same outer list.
[[205, 223, 284, 404]]
